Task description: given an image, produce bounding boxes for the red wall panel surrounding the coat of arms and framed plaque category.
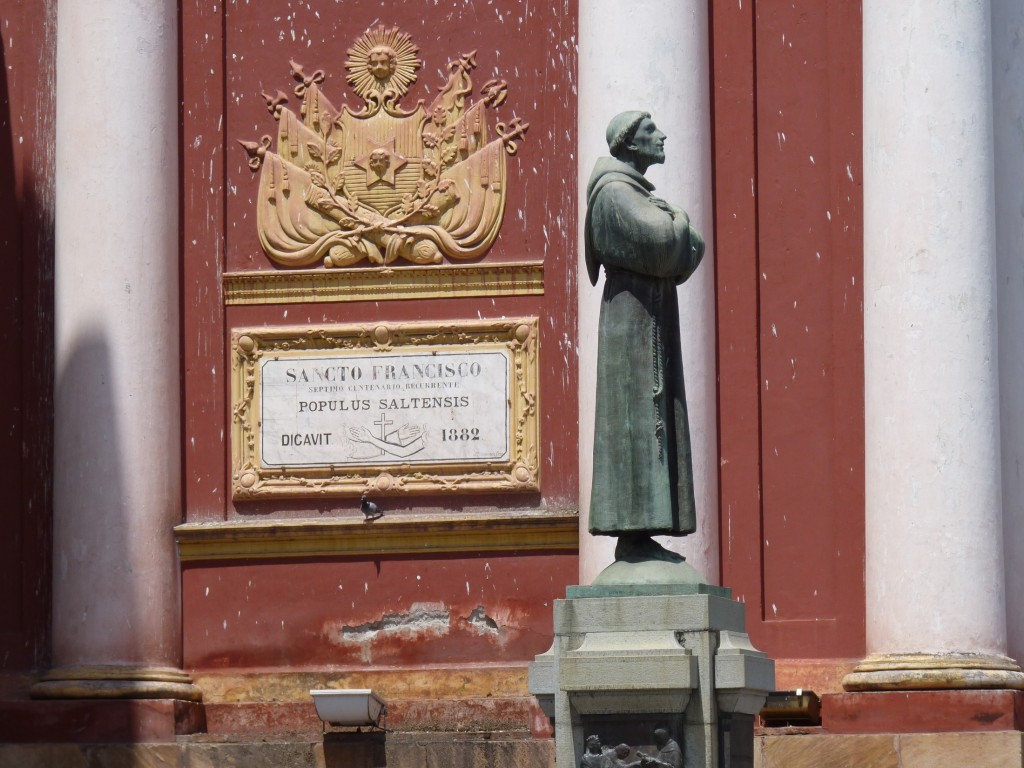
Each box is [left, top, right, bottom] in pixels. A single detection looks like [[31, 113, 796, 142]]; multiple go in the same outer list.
[[182, 0, 579, 521]]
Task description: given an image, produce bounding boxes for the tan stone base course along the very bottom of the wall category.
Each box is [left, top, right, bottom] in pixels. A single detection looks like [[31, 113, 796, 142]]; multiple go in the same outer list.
[[0, 729, 1024, 768]]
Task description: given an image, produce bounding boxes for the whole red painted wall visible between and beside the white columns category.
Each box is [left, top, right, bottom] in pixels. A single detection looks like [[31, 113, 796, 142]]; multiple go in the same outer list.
[[0, 0, 864, 696]]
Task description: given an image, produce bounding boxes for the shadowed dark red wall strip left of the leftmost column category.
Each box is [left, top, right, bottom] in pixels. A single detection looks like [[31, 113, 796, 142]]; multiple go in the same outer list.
[[0, 0, 56, 679]]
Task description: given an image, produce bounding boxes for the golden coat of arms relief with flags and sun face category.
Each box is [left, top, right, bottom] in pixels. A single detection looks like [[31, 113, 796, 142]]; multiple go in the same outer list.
[[240, 26, 529, 267]]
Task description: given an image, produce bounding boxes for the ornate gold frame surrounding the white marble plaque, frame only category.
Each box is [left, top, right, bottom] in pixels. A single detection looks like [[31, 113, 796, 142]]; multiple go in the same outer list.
[[230, 317, 541, 500]]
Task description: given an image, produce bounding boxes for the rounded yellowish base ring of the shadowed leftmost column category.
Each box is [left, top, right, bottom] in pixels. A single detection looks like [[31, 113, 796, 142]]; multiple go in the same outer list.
[[30, 666, 203, 701]]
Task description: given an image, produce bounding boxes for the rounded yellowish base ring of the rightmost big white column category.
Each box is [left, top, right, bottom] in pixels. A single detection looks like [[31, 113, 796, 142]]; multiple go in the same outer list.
[[843, 653, 1024, 691]]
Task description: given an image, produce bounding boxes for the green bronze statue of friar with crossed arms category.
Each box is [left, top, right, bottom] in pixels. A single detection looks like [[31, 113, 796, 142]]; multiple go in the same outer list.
[[585, 112, 705, 563]]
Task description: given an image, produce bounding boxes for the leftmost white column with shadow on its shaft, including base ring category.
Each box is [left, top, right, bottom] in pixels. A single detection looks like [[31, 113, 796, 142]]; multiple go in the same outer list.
[[34, 0, 198, 698]]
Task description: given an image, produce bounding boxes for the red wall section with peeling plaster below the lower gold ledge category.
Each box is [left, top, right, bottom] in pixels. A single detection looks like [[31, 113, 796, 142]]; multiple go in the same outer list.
[[182, 553, 578, 670]]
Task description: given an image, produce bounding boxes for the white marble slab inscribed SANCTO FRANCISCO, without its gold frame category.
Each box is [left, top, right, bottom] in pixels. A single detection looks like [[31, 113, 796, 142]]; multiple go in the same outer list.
[[260, 349, 511, 467]]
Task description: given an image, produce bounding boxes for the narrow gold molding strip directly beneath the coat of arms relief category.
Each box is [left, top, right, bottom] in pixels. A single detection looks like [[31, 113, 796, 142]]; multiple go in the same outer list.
[[224, 261, 544, 305]]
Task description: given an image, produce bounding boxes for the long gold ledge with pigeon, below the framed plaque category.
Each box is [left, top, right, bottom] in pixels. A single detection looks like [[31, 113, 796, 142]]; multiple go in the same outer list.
[[174, 511, 580, 562]]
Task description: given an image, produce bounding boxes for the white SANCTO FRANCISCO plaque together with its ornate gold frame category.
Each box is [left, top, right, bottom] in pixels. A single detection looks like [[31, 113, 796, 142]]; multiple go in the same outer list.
[[231, 318, 540, 499]]
